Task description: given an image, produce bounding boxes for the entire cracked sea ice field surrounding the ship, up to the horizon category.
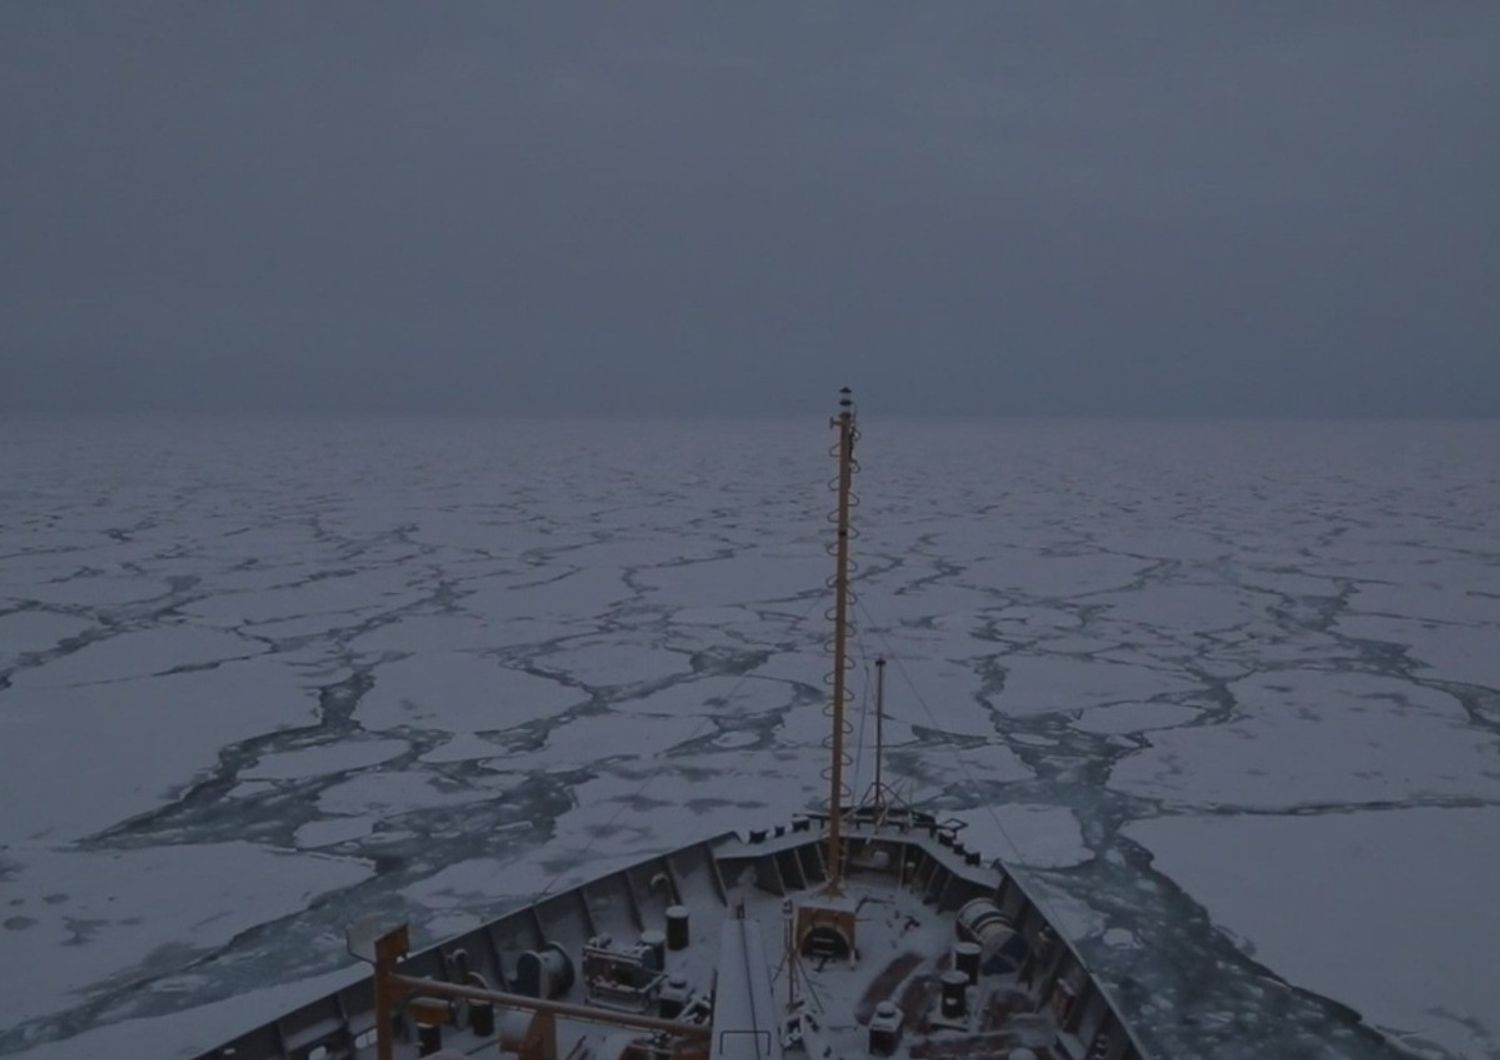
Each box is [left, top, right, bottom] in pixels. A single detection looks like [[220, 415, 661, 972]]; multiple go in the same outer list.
[[0, 417, 1500, 1060]]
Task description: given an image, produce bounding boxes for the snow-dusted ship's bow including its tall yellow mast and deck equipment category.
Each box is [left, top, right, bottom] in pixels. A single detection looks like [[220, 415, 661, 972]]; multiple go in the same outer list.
[[200, 388, 1146, 1060]]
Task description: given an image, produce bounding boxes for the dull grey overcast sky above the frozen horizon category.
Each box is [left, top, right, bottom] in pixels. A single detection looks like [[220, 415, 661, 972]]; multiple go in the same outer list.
[[0, 0, 1500, 415]]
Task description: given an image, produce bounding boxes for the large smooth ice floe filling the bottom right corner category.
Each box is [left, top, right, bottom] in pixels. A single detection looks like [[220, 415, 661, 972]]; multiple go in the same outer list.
[[1125, 807, 1500, 1057]]
